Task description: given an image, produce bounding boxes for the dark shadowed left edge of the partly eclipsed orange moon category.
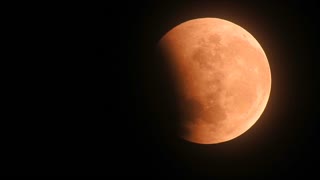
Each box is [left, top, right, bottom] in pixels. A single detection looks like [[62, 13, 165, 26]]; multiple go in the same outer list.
[[140, 46, 198, 143]]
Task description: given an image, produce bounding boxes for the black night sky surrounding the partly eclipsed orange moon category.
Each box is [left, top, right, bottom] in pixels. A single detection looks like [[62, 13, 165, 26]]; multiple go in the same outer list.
[[0, 0, 320, 179]]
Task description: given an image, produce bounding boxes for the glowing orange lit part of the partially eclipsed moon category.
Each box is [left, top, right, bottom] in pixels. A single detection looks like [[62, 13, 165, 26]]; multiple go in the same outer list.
[[158, 18, 271, 144]]
